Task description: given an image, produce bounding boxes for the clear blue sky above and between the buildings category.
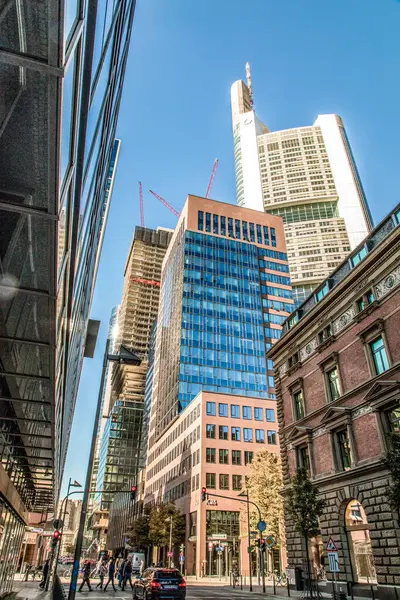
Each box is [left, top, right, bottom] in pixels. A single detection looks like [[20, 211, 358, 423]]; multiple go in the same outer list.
[[60, 0, 400, 494]]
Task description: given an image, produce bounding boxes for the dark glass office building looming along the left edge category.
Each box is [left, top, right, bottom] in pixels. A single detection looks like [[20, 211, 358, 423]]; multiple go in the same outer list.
[[0, 0, 135, 591]]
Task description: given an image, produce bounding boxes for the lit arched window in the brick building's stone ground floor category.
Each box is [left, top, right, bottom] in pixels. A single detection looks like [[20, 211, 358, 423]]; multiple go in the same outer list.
[[345, 500, 376, 583]]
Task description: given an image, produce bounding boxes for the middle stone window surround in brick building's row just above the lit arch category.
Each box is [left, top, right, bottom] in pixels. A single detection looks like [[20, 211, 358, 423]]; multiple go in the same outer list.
[[321, 406, 358, 473]]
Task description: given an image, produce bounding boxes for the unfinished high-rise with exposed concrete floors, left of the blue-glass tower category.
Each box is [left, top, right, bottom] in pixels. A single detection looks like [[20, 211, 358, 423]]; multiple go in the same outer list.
[[90, 227, 172, 552]]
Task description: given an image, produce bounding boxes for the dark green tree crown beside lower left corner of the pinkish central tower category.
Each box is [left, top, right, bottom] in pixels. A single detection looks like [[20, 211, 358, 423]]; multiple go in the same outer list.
[[149, 502, 186, 547]]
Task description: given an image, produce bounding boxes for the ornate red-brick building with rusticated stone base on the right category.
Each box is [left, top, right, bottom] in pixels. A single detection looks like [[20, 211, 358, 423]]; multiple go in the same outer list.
[[268, 206, 400, 598]]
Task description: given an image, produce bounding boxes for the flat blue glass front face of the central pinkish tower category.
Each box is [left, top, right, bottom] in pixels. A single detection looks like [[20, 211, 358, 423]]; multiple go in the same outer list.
[[179, 231, 268, 412]]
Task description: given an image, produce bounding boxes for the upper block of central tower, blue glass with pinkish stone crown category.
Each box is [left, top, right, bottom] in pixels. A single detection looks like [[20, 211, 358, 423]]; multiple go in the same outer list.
[[149, 196, 292, 446]]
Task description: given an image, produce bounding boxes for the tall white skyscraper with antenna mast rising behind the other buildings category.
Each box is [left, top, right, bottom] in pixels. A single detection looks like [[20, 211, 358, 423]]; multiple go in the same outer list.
[[231, 70, 372, 304]]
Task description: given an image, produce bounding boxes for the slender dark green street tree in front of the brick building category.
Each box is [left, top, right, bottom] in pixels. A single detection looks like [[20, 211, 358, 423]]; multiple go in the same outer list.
[[287, 469, 325, 596]]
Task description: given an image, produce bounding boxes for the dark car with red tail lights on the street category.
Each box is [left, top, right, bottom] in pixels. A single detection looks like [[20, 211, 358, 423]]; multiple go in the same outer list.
[[133, 568, 186, 600]]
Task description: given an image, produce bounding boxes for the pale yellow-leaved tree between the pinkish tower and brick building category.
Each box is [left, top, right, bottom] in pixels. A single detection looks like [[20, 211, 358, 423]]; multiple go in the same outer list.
[[247, 450, 284, 540]]
